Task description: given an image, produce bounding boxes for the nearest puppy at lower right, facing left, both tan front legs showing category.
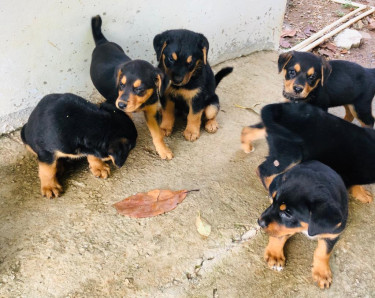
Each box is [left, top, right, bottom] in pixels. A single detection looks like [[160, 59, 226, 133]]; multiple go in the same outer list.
[[258, 161, 348, 289]]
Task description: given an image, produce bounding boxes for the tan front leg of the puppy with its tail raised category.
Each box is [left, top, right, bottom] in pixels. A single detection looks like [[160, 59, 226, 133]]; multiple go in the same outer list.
[[144, 103, 173, 160]]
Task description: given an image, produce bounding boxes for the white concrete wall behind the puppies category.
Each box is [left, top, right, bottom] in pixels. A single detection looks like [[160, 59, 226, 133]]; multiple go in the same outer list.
[[0, 0, 286, 134]]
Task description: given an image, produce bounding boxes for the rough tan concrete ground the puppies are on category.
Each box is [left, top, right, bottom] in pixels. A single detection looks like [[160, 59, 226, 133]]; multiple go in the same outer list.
[[0, 52, 375, 297]]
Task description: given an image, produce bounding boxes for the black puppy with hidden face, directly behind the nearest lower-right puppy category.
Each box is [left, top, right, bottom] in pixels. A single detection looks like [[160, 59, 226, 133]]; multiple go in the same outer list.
[[257, 103, 375, 203]]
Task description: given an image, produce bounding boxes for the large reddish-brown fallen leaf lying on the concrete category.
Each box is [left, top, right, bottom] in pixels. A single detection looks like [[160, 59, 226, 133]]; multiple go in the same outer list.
[[113, 189, 197, 218]]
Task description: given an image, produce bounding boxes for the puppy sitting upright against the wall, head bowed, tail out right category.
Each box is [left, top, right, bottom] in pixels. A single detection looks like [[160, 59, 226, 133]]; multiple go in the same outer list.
[[154, 30, 233, 141]]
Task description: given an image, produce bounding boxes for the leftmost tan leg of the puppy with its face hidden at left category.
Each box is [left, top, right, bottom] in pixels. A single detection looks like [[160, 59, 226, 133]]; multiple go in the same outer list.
[[39, 160, 62, 199]]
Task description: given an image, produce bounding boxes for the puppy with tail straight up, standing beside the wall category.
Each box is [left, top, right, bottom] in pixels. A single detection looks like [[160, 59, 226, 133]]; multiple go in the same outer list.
[[90, 16, 173, 159]]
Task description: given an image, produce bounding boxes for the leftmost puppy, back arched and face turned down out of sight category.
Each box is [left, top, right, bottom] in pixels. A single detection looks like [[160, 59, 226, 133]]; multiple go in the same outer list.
[[21, 93, 137, 198]]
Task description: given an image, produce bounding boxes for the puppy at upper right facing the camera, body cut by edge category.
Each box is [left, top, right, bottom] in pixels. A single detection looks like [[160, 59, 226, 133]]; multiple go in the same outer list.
[[278, 51, 375, 127]]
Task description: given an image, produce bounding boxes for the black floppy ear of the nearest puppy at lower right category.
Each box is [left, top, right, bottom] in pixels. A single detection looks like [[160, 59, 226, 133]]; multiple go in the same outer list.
[[308, 202, 343, 236]]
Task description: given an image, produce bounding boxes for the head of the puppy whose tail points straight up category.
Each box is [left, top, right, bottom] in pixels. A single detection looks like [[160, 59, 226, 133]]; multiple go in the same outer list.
[[116, 60, 164, 113]]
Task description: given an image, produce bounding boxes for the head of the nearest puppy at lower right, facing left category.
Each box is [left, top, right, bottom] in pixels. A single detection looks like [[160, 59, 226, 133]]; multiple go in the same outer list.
[[258, 164, 347, 237]]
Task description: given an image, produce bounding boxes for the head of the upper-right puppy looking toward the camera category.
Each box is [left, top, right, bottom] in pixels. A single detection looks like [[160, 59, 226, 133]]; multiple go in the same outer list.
[[278, 51, 332, 101]]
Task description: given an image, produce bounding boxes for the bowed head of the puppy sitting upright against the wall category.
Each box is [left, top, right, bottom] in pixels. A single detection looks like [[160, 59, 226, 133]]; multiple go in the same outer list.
[[154, 30, 209, 86]]
